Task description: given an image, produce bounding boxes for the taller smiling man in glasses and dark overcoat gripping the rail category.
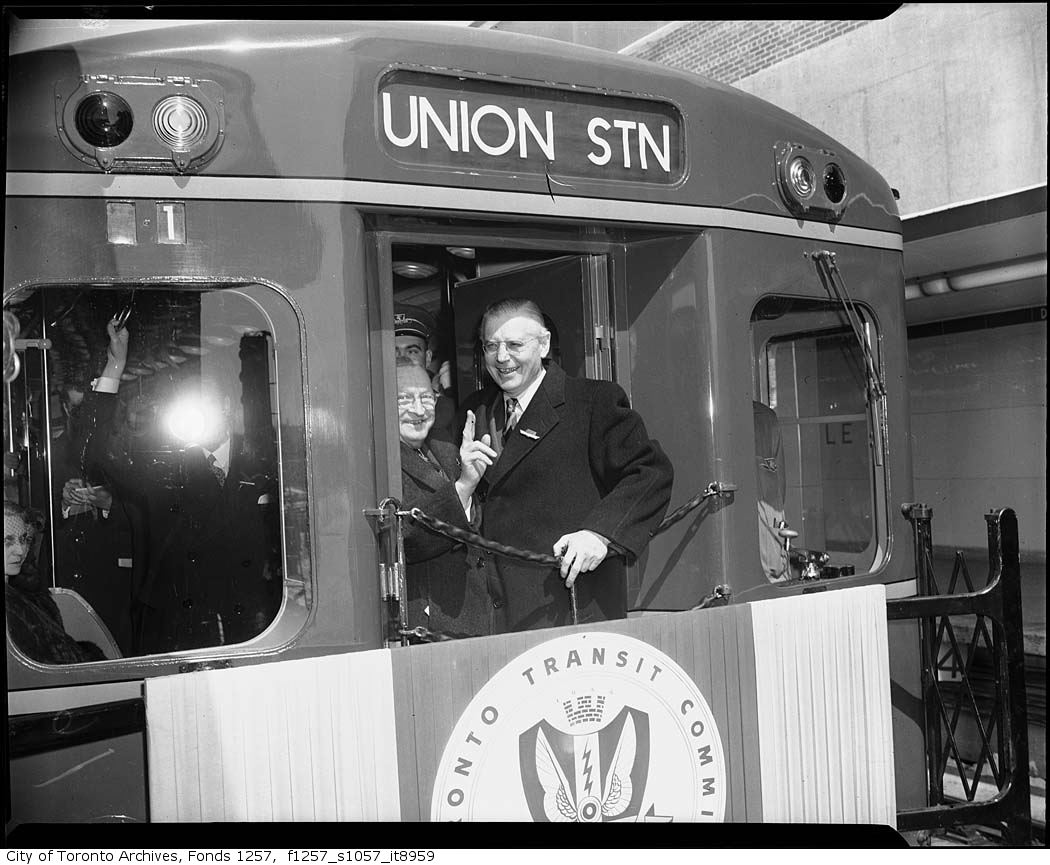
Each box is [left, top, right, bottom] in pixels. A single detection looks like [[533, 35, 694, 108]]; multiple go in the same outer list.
[[463, 299, 674, 631]]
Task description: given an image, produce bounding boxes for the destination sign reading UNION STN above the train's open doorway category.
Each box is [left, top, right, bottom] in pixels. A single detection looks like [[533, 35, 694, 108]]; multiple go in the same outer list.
[[377, 69, 685, 184]]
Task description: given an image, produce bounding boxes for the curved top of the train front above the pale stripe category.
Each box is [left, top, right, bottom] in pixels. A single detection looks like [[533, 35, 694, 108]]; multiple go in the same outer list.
[[7, 20, 900, 233]]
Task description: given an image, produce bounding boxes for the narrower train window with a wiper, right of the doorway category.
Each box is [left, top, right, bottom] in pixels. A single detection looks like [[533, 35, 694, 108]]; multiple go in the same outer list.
[[752, 297, 882, 582]]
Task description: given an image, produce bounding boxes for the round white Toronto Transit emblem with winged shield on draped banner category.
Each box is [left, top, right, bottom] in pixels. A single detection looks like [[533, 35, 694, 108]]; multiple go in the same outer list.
[[431, 632, 726, 823]]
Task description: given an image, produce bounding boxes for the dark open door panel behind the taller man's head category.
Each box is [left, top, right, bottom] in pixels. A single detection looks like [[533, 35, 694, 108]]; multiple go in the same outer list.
[[453, 255, 610, 399]]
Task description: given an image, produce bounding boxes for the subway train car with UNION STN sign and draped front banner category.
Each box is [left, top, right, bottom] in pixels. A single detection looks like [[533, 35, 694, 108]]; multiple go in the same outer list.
[[4, 21, 1016, 826]]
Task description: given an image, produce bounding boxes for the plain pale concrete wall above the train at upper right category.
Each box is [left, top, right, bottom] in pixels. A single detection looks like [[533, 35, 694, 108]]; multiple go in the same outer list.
[[692, 3, 1047, 216]]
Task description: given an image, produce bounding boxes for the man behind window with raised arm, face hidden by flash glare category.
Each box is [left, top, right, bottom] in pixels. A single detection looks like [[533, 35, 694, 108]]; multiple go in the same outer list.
[[86, 322, 284, 654]]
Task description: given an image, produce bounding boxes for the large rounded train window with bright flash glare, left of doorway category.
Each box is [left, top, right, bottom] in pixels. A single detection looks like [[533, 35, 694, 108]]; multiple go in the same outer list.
[[4, 284, 312, 663]]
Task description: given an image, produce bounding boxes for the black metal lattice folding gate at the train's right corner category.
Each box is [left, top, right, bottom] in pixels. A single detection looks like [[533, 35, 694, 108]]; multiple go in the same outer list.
[[887, 504, 1032, 845]]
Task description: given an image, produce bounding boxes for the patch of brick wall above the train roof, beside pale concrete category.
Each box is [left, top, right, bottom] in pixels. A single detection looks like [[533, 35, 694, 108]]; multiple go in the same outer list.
[[629, 20, 872, 84]]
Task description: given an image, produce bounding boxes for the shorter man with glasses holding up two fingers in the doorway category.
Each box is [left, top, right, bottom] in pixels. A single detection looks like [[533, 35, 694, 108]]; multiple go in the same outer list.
[[397, 357, 502, 638]]
